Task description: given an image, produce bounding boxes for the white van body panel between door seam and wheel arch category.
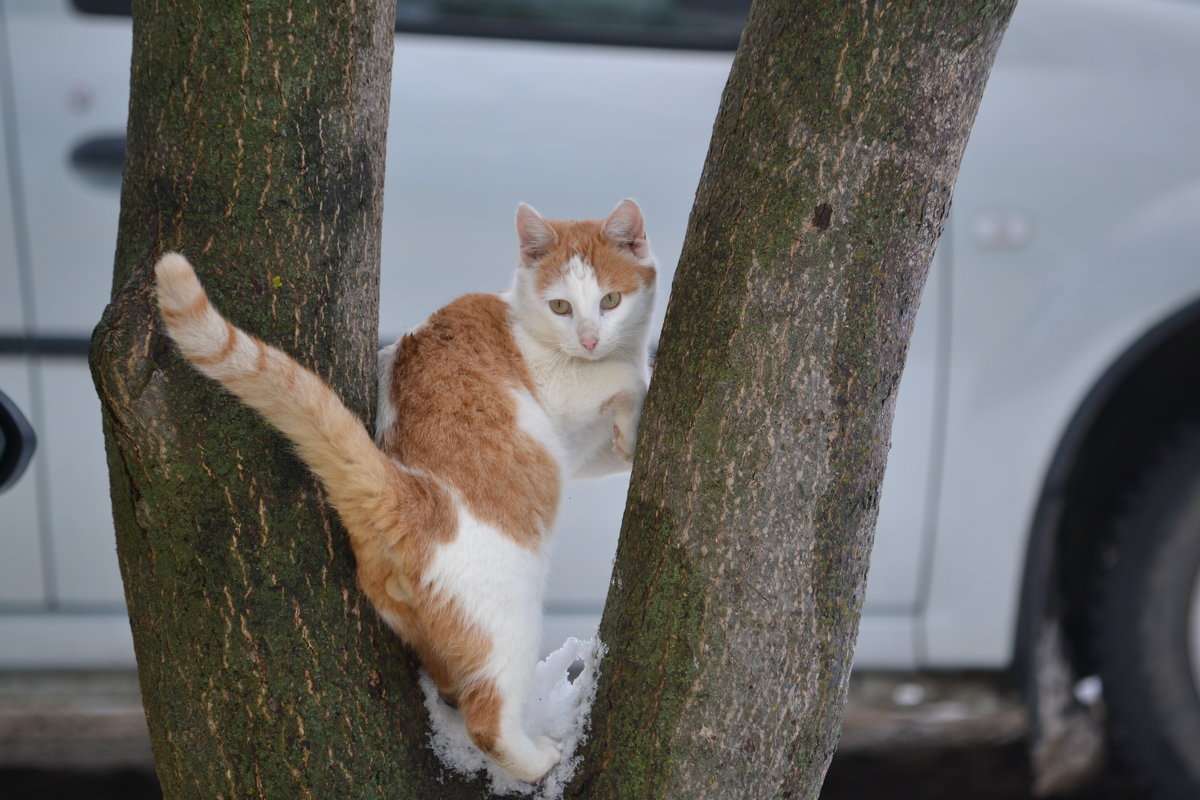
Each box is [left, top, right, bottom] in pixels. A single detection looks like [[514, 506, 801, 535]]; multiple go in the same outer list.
[[918, 0, 1200, 668]]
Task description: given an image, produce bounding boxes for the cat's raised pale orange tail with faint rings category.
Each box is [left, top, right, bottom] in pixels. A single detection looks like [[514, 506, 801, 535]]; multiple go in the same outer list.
[[155, 253, 400, 539]]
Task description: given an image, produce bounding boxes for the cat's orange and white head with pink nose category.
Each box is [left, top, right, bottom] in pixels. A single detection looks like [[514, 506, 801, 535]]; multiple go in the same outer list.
[[512, 199, 655, 360]]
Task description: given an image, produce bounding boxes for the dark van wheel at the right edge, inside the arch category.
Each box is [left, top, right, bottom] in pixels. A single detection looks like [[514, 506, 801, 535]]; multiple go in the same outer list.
[[1093, 426, 1200, 800]]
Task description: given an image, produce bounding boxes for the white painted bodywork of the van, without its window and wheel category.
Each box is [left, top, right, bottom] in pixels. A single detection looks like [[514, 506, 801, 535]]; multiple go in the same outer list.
[[0, 0, 1200, 669]]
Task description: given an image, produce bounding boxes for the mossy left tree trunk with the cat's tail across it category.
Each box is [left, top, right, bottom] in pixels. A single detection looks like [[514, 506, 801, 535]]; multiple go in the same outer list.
[[91, 0, 480, 800]]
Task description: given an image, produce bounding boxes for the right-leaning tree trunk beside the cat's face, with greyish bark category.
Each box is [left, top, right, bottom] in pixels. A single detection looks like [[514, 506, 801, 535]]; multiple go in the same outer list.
[[571, 0, 1015, 800]]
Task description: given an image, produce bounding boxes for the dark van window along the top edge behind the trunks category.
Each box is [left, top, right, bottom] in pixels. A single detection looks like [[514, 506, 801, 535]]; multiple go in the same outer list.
[[74, 0, 750, 50]]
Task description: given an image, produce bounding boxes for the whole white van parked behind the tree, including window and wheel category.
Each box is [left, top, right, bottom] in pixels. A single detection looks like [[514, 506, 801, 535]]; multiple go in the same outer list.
[[0, 0, 1200, 798]]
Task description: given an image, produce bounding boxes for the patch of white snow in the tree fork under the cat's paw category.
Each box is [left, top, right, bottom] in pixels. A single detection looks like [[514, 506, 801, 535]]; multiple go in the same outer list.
[[421, 637, 605, 800]]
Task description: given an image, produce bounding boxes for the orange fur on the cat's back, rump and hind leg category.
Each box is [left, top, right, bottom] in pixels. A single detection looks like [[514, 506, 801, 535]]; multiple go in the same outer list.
[[355, 295, 560, 743]]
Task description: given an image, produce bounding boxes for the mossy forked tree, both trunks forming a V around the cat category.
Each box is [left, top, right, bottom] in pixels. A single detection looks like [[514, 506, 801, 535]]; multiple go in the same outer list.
[[92, 0, 1012, 799]]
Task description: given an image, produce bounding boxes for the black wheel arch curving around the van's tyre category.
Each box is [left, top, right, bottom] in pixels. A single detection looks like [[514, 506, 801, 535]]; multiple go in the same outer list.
[[1014, 299, 1200, 790]]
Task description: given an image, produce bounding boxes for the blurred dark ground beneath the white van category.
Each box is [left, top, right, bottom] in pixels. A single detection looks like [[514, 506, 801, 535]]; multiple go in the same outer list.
[[0, 673, 1141, 800]]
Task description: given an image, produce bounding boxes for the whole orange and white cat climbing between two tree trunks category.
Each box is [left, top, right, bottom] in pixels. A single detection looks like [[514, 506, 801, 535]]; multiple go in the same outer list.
[[155, 199, 655, 783]]
